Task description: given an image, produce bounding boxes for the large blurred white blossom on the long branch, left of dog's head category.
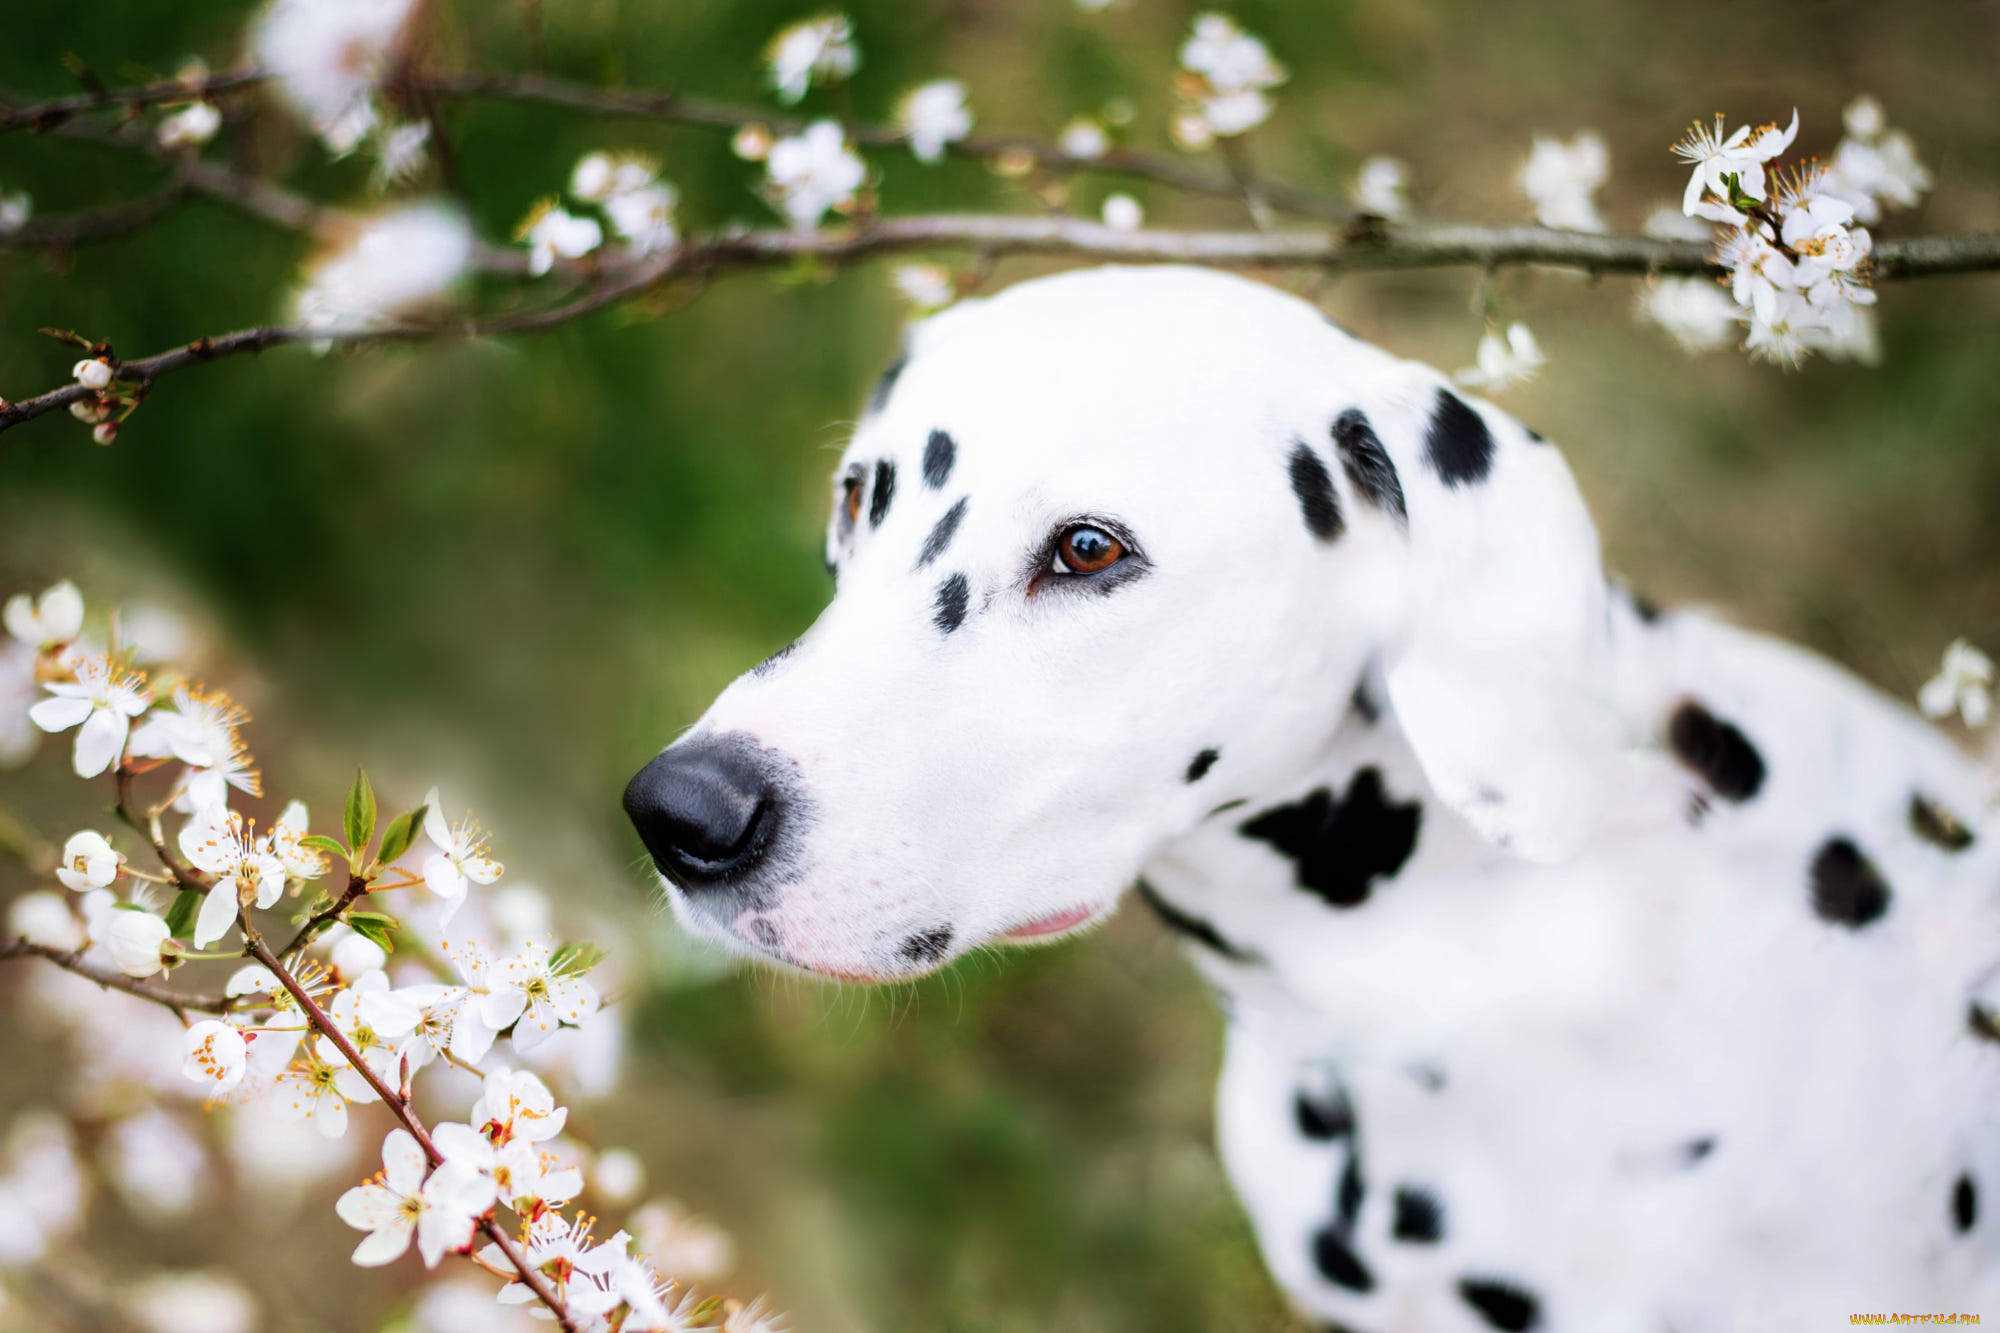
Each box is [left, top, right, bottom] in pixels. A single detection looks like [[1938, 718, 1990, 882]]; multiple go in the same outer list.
[[294, 200, 472, 352]]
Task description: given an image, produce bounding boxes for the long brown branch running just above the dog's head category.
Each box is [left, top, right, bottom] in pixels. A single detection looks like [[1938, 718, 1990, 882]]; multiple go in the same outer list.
[[0, 214, 2000, 430]]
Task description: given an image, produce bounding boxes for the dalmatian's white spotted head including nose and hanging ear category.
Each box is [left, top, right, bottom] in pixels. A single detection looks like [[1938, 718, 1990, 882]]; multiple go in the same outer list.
[[626, 268, 1604, 979]]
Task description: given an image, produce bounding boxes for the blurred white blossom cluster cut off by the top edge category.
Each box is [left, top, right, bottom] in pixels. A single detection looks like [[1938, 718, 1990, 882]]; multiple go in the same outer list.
[[250, 0, 416, 156]]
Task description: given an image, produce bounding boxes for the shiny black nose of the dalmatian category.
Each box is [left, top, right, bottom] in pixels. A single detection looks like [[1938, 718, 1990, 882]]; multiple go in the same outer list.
[[624, 735, 780, 889]]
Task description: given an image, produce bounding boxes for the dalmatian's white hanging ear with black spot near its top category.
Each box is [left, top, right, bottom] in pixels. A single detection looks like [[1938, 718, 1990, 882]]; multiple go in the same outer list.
[[1360, 370, 1622, 861]]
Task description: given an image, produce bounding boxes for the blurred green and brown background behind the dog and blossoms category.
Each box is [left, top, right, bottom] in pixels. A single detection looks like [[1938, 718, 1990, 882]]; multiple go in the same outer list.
[[0, 0, 2000, 1333]]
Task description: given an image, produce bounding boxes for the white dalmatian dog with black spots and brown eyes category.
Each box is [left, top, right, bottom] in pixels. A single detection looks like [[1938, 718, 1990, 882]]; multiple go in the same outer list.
[[626, 268, 2000, 1333]]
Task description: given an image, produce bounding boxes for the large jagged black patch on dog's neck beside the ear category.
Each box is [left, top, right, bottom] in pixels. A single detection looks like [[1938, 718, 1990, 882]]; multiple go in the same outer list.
[[1238, 767, 1424, 907]]
